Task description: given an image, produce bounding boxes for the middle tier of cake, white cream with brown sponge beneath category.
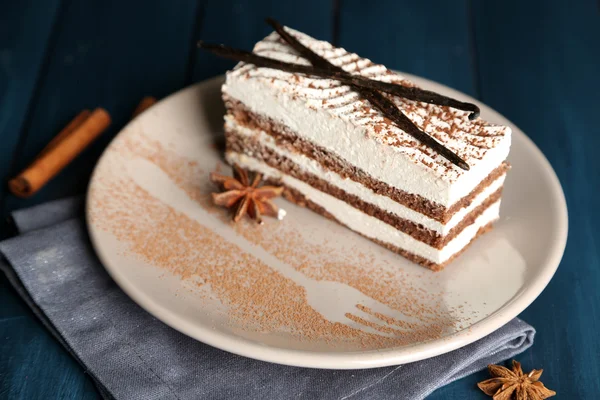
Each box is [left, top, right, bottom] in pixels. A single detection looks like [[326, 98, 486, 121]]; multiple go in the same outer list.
[[225, 117, 505, 249]]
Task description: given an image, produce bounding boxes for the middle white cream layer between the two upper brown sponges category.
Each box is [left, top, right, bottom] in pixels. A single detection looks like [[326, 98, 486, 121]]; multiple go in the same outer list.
[[225, 119, 506, 236]]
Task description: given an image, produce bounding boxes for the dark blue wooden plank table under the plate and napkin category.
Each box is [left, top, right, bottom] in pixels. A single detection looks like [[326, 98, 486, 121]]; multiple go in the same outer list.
[[0, 0, 600, 399]]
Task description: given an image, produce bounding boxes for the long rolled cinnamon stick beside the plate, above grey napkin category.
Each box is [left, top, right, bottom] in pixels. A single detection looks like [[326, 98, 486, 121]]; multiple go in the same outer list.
[[8, 108, 111, 197]]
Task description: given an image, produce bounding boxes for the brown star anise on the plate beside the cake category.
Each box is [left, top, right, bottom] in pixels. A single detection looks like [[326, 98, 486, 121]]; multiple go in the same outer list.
[[210, 165, 283, 224]]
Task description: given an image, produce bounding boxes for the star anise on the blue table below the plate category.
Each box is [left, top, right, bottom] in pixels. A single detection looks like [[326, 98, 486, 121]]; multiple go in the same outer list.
[[477, 360, 556, 400]]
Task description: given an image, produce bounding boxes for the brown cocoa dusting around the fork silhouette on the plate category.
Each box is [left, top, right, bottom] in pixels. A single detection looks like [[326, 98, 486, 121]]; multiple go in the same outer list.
[[90, 129, 467, 349]]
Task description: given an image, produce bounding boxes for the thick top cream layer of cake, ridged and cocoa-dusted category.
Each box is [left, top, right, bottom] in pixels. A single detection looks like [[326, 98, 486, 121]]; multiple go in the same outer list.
[[223, 29, 510, 208]]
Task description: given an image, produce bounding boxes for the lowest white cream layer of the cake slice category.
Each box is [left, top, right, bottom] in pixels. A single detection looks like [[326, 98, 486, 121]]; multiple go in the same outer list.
[[226, 152, 500, 264]]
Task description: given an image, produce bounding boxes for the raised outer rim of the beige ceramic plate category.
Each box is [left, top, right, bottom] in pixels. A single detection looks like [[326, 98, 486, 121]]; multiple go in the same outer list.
[[85, 72, 568, 369]]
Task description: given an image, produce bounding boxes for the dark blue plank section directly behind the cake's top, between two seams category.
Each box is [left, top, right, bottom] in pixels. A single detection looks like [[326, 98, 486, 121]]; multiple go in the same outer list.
[[339, 0, 477, 96]]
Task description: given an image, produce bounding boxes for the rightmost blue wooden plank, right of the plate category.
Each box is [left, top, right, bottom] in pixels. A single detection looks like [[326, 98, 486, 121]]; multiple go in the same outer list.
[[474, 0, 600, 399]]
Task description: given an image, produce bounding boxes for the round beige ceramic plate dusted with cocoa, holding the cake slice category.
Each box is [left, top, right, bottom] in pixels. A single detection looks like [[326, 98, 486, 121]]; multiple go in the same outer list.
[[87, 77, 567, 369]]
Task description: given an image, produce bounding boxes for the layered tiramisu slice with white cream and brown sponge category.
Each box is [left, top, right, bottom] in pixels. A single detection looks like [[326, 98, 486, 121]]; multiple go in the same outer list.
[[222, 28, 511, 270]]
